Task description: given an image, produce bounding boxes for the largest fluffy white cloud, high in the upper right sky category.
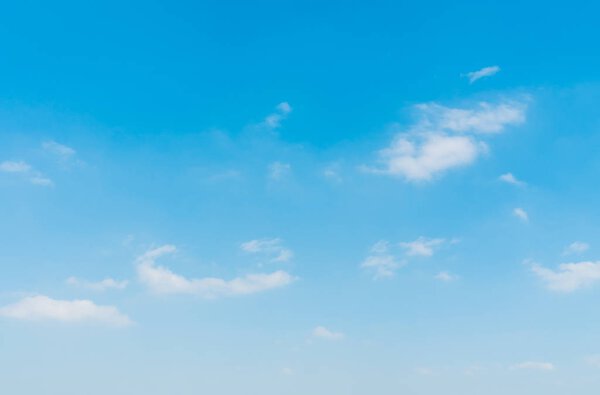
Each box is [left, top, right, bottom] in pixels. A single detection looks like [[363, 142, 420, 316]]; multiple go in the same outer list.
[[362, 102, 526, 182]]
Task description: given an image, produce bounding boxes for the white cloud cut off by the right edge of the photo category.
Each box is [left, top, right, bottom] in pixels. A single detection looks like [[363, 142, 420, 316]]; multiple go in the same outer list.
[[531, 261, 600, 292]]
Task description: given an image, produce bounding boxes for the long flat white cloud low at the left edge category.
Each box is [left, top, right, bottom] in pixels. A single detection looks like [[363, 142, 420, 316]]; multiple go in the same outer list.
[[0, 295, 132, 326]]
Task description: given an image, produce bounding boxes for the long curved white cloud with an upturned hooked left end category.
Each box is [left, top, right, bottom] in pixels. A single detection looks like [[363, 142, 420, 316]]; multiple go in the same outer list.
[[137, 245, 294, 298]]
